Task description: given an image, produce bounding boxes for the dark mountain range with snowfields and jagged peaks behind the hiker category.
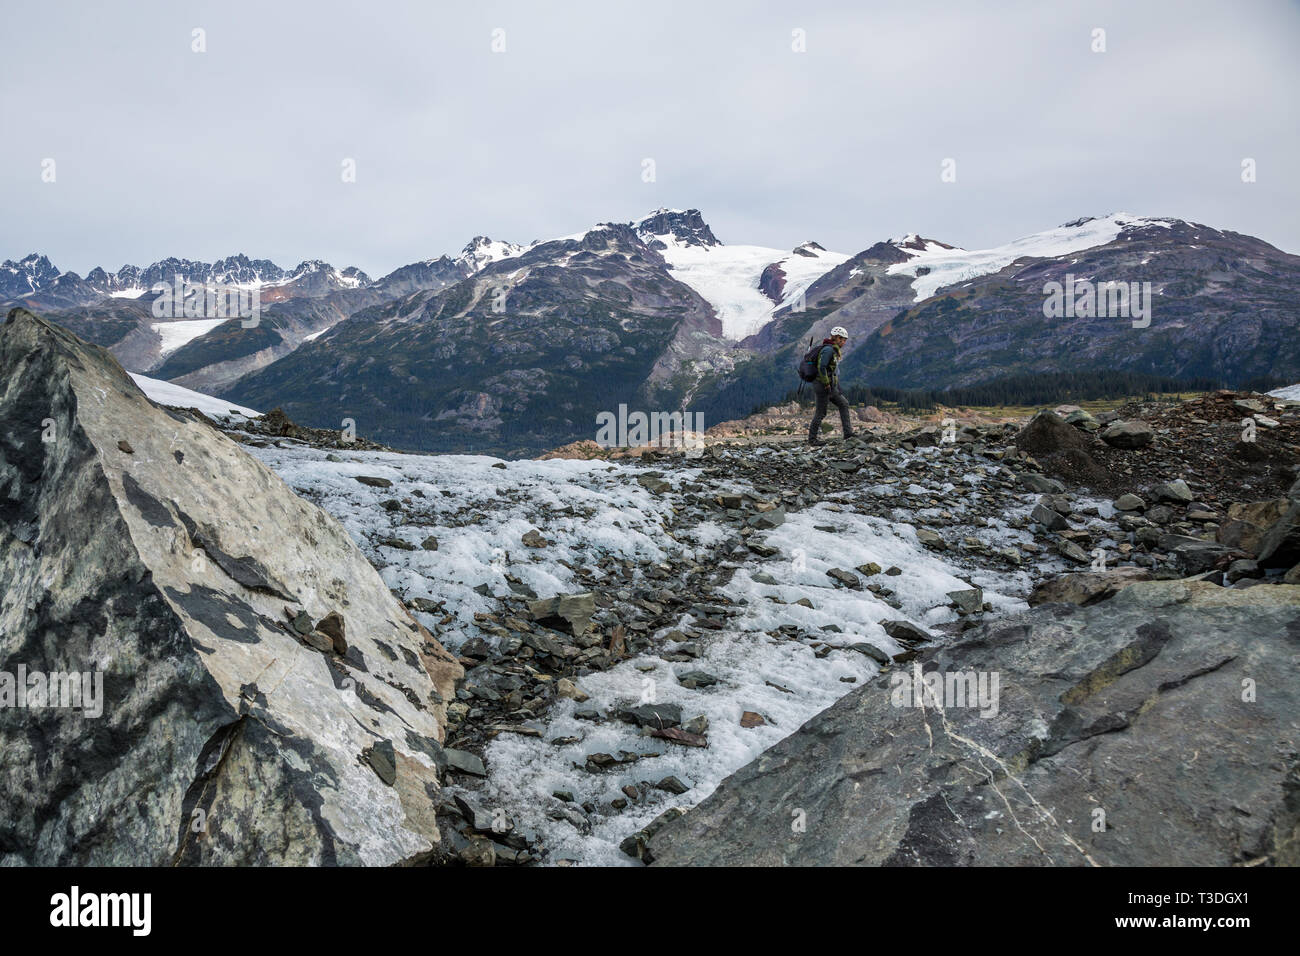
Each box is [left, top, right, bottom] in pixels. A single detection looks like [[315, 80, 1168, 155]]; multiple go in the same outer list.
[[10, 209, 1300, 454]]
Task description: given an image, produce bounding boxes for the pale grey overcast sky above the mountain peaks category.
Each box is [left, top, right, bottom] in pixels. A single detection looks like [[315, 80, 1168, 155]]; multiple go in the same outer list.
[[0, 0, 1300, 277]]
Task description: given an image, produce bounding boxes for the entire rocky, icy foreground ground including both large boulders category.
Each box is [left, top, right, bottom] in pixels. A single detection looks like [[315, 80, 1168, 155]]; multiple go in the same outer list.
[[0, 306, 1300, 865]]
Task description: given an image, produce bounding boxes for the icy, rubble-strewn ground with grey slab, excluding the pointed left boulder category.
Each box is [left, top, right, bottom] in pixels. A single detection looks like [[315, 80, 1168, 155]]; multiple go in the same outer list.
[[215, 374, 1300, 865]]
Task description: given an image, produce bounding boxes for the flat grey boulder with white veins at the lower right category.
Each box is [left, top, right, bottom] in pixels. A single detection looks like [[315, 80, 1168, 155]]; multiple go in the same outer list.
[[647, 581, 1300, 866]]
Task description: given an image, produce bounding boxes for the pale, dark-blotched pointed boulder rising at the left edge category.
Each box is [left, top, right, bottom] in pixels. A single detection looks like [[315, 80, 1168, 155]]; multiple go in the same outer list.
[[0, 310, 462, 866]]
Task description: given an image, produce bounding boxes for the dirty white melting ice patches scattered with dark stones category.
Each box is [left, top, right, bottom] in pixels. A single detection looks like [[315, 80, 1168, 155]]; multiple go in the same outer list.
[[248, 446, 1055, 864]]
